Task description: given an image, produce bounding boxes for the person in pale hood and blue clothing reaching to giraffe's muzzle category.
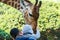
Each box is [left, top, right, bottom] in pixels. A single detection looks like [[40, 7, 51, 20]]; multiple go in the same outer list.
[[15, 24, 40, 40]]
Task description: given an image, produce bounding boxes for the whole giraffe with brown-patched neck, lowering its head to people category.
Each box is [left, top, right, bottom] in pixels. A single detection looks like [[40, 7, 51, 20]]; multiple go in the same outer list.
[[0, 0, 42, 33]]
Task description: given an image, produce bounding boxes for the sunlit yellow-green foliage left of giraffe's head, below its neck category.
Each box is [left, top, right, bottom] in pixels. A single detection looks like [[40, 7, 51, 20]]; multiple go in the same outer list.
[[0, 3, 24, 33]]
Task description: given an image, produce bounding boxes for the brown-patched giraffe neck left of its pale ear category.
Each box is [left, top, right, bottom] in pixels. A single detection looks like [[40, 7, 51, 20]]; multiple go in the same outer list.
[[0, 0, 20, 10]]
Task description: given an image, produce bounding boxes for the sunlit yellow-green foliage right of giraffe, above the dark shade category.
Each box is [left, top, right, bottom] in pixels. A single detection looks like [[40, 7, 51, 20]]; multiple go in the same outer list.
[[38, 1, 60, 31]]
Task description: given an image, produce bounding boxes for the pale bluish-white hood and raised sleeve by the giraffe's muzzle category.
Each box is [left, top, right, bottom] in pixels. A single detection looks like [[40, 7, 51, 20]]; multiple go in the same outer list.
[[22, 24, 40, 39]]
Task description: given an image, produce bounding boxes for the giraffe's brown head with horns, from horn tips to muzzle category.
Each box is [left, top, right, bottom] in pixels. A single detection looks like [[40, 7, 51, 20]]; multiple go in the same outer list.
[[24, 0, 42, 33]]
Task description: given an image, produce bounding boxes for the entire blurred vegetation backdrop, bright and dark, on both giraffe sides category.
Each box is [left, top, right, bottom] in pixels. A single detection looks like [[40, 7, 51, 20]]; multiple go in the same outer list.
[[0, 0, 60, 40]]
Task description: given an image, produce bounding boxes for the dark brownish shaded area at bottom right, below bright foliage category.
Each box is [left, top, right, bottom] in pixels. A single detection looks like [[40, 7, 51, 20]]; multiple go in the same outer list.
[[39, 28, 60, 40]]
